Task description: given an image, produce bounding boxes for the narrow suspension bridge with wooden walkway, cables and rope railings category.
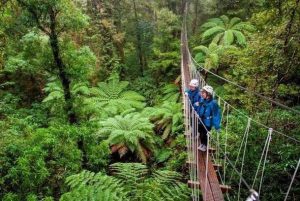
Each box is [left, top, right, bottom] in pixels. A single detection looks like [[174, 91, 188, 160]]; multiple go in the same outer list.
[[181, 3, 300, 201]]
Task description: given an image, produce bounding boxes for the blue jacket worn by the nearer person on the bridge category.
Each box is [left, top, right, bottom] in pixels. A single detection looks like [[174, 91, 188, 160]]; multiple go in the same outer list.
[[195, 98, 221, 130]]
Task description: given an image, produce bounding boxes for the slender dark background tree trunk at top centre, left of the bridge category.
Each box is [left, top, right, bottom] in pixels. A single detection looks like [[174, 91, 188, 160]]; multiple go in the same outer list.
[[133, 0, 145, 77]]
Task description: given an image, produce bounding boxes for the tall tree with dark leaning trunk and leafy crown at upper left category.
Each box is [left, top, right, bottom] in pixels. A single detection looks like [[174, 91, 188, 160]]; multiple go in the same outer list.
[[13, 0, 87, 124]]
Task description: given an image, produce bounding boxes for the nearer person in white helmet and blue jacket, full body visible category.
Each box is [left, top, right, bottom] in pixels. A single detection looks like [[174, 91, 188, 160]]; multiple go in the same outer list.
[[194, 85, 221, 151]]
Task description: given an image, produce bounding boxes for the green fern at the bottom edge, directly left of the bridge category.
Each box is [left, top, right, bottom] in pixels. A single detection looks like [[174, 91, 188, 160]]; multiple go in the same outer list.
[[111, 163, 190, 201]]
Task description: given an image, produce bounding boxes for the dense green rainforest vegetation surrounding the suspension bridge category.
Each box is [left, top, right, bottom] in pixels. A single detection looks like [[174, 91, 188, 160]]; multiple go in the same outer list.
[[0, 0, 300, 201]]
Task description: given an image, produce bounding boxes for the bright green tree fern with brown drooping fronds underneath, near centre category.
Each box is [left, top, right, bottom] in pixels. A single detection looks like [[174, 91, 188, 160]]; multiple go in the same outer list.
[[97, 113, 155, 162]]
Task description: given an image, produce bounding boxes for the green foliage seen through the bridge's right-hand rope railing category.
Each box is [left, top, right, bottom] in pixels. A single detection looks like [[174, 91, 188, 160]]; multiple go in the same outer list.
[[216, 109, 300, 200]]
